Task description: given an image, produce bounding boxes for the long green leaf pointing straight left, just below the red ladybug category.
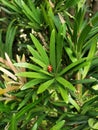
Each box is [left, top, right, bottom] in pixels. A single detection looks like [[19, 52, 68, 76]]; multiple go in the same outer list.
[[16, 72, 49, 79]]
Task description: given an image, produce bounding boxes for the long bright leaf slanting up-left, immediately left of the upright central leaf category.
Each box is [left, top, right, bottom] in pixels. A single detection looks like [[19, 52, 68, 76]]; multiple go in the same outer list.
[[30, 34, 49, 65]]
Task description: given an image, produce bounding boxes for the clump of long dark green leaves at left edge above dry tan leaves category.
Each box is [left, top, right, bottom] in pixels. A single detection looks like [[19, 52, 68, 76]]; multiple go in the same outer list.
[[0, 20, 17, 58]]
